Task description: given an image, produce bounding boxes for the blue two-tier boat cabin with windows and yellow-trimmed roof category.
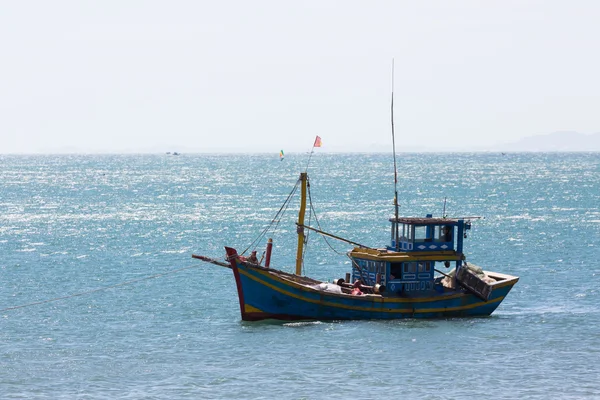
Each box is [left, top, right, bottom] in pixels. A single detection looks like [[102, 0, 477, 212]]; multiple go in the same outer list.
[[350, 215, 471, 297]]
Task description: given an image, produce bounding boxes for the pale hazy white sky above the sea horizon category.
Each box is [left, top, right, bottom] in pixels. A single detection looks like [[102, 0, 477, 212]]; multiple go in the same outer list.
[[0, 0, 600, 153]]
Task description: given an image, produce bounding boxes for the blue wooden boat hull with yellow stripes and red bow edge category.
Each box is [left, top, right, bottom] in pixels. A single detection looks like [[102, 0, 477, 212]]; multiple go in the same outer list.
[[226, 248, 519, 321]]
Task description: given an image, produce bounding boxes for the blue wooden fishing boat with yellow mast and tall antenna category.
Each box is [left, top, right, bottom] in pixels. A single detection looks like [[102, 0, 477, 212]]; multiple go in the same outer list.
[[192, 74, 519, 321]]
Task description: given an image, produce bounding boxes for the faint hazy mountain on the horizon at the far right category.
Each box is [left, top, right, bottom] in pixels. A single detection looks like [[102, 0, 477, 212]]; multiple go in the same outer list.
[[493, 131, 600, 152]]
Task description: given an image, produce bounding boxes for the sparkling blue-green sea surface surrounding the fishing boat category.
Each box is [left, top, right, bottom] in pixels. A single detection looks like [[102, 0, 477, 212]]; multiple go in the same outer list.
[[0, 149, 600, 399]]
